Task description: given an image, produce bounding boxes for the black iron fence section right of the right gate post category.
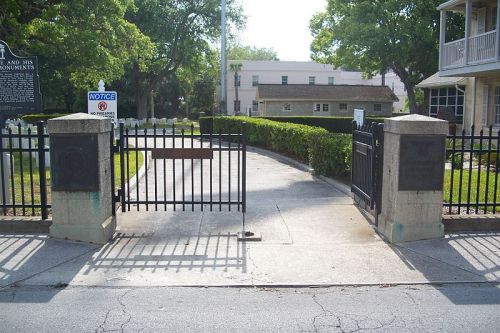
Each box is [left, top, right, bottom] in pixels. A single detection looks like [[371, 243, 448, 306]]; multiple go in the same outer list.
[[443, 126, 500, 214]]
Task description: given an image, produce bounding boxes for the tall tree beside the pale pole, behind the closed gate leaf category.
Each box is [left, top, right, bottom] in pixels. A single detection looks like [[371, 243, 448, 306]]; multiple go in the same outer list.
[[126, 0, 241, 118]]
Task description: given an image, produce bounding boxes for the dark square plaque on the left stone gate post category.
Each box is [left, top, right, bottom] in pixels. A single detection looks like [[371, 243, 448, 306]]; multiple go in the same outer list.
[[50, 134, 99, 192]]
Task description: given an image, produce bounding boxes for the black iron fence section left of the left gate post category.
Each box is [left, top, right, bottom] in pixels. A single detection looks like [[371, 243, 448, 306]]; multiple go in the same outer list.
[[0, 122, 51, 219]]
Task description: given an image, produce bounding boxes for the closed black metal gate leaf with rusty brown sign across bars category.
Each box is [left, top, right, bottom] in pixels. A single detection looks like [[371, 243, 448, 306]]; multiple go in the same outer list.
[[112, 124, 247, 213]]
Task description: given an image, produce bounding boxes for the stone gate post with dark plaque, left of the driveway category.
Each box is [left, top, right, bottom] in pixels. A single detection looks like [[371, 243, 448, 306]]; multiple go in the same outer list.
[[48, 113, 116, 244]]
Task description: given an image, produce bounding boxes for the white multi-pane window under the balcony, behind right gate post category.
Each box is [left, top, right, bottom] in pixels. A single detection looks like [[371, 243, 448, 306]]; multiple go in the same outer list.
[[429, 87, 465, 124]]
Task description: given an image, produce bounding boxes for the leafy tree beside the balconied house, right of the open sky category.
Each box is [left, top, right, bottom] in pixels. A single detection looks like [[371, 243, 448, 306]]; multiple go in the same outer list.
[[310, 0, 462, 113]]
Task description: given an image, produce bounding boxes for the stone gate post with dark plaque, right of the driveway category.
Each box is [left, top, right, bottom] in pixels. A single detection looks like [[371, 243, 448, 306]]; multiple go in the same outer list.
[[378, 115, 448, 243]]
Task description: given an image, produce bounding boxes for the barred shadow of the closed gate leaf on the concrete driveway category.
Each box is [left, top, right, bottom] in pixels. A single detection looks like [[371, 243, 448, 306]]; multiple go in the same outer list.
[[83, 233, 247, 275]]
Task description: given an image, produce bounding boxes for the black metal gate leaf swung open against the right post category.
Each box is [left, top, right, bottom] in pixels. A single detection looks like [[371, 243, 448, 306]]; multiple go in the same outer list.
[[351, 122, 384, 224]]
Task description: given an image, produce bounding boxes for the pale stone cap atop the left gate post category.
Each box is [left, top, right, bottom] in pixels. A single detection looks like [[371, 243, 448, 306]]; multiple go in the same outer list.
[[48, 113, 113, 134]]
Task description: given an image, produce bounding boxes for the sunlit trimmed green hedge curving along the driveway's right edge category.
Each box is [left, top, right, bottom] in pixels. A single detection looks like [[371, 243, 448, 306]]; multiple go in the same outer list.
[[207, 117, 352, 176]]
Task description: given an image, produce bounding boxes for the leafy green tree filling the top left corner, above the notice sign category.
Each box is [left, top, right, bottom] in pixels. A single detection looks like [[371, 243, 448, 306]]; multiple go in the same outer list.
[[0, 0, 152, 111]]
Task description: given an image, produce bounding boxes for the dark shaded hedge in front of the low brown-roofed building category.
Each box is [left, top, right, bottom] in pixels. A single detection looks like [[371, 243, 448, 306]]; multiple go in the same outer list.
[[259, 116, 385, 134]]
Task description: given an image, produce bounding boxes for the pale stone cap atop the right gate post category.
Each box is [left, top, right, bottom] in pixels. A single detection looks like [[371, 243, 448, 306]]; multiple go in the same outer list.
[[384, 114, 448, 135]]
